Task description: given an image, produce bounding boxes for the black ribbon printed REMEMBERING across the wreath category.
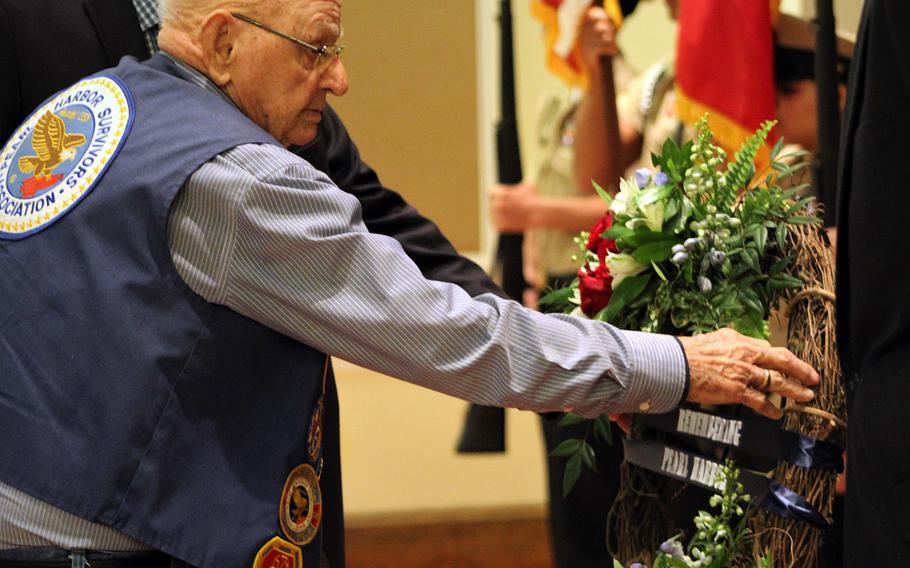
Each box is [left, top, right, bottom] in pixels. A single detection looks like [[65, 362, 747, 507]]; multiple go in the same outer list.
[[635, 407, 844, 473]]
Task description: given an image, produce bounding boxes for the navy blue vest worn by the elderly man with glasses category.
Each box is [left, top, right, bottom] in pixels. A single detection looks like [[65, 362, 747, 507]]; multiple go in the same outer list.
[[0, 56, 340, 568]]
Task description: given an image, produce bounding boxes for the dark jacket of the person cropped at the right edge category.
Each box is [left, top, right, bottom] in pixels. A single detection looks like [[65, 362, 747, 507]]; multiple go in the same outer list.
[[837, 0, 910, 567]]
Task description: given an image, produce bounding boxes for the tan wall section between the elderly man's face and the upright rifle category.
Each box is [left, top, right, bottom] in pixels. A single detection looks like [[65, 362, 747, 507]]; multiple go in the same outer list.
[[330, 0, 480, 250]]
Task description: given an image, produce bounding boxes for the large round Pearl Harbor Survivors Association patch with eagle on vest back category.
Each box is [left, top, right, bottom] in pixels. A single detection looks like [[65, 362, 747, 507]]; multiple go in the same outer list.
[[0, 75, 133, 239]]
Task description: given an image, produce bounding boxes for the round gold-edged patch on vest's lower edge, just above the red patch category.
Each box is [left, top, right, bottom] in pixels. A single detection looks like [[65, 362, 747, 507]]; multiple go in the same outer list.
[[278, 464, 322, 546]]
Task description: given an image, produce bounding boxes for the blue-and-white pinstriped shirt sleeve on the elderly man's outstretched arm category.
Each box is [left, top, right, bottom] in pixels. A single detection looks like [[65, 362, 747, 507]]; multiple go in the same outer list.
[[168, 145, 686, 416]]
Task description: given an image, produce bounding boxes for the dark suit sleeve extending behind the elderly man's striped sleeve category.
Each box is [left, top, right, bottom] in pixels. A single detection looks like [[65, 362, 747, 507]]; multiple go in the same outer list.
[[301, 107, 505, 297]]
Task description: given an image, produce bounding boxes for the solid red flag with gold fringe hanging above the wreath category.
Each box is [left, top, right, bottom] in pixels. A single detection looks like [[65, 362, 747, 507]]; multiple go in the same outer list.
[[676, 0, 779, 160]]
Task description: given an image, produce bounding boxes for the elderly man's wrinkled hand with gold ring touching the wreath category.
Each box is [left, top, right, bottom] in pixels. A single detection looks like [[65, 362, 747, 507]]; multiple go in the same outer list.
[[679, 329, 819, 419]]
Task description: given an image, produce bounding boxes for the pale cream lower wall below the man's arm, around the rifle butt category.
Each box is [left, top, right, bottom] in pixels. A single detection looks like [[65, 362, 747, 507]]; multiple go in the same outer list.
[[335, 361, 545, 518]]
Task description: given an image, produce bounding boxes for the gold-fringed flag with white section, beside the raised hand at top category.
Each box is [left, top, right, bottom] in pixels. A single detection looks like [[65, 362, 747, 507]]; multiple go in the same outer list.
[[531, 0, 638, 88]]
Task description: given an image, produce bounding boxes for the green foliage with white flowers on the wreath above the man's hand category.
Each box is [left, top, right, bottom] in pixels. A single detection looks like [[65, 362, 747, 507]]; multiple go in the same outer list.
[[541, 117, 819, 493]]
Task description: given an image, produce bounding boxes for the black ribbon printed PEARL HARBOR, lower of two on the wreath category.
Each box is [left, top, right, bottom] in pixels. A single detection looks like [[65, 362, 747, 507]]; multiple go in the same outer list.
[[623, 439, 829, 528]]
